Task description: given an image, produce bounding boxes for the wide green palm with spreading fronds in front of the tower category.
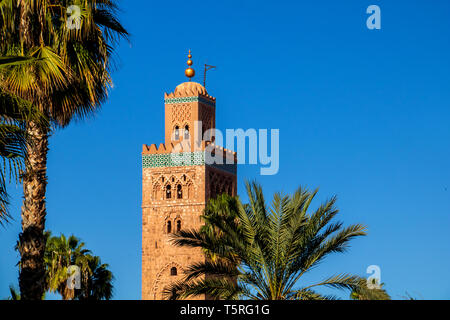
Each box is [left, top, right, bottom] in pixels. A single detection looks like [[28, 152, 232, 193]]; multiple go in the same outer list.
[[165, 183, 366, 300]]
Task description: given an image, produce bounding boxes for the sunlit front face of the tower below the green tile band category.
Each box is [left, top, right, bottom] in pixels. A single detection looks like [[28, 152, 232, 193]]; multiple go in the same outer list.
[[142, 162, 206, 300]]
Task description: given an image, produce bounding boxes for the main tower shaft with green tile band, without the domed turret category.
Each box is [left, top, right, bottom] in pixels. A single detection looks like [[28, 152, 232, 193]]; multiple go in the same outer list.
[[142, 146, 237, 300]]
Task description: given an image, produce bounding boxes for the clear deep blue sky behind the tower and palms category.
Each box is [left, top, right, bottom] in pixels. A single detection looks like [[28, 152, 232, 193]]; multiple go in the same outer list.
[[0, 0, 450, 299]]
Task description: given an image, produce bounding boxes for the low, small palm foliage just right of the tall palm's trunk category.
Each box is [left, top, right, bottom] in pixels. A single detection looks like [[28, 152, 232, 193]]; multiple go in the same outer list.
[[44, 232, 114, 300]]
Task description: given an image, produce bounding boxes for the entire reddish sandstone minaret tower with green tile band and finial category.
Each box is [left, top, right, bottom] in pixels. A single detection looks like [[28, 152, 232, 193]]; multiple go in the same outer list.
[[142, 51, 237, 300]]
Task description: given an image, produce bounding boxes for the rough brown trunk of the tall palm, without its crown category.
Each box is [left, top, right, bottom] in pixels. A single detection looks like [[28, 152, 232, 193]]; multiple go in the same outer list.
[[19, 122, 50, 300]]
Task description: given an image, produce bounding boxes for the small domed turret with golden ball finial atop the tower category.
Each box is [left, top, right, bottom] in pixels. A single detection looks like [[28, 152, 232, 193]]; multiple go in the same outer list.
[[164, 50, 216, 150]]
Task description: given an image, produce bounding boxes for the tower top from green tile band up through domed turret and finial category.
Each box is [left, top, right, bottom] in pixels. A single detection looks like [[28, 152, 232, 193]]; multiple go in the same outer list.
[[142, 51, 237, 175]]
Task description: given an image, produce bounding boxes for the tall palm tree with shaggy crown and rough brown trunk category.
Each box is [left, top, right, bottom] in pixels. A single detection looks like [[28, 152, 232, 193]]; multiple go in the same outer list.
[[0, 0, 128, 300]]
